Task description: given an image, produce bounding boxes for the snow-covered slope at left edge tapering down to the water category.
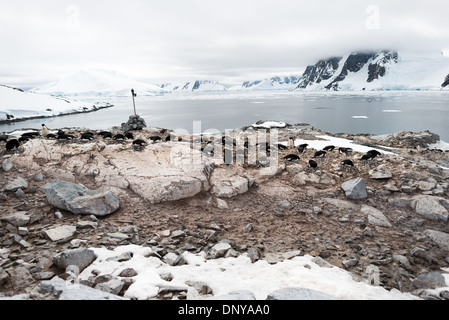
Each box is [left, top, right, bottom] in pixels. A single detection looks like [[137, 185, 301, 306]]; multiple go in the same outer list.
[[0, 85, 112, 122]]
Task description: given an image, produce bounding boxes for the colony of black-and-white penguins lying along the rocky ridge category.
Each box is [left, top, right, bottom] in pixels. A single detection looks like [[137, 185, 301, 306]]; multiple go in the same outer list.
[[0, 124, 381, 169]]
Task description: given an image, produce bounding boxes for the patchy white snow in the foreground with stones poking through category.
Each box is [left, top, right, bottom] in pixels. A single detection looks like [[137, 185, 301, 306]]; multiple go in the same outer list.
[[79, 245, 418, 300]]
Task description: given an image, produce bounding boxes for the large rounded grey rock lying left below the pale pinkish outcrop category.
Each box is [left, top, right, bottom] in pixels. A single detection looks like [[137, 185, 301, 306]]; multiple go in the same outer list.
[[44, 180, 120, 216]]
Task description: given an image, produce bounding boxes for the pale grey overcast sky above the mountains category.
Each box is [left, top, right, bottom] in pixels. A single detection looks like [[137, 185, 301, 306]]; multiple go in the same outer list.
[[0, 0, 449, 87]]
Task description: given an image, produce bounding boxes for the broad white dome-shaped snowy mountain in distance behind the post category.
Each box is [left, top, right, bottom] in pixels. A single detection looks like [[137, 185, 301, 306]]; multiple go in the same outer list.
[[30, 69, 165, 97]]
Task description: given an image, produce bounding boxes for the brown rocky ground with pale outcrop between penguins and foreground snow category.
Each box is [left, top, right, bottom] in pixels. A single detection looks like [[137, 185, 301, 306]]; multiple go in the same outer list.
[[0, 122, 449, 299]]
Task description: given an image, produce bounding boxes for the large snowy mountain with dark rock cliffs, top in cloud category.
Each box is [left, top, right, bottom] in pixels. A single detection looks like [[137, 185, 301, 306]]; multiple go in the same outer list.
[[296, 50, 449, 91]]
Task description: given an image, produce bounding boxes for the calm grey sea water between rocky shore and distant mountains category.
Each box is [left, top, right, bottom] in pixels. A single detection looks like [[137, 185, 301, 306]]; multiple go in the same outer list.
[[0, 92, 449, 141]]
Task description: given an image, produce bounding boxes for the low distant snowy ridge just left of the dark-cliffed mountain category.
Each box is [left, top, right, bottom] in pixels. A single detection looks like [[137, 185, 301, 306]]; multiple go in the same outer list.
[[228, 76, 301, 91]]
